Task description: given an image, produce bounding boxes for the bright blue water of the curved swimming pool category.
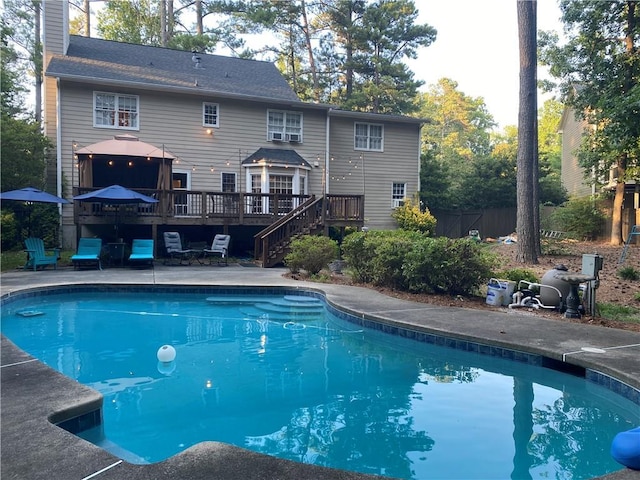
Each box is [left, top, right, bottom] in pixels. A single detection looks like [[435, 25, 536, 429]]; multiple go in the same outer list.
[[2, 292, 640, 479]]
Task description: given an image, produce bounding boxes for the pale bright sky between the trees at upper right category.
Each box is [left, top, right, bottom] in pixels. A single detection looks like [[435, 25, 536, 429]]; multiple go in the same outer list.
[[407, 0, 562, 129]]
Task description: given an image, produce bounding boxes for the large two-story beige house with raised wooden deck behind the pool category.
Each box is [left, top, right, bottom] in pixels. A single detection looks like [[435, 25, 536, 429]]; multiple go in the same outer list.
[[43, 1, 424, 263]]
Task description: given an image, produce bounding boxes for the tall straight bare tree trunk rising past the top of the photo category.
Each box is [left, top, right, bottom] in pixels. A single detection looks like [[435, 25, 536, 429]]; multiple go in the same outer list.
[[516, 0, 540, 264]]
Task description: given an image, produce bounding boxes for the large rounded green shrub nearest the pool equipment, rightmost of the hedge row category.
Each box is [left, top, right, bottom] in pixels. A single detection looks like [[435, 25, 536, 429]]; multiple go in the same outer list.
[[403, 237, 496, 295]]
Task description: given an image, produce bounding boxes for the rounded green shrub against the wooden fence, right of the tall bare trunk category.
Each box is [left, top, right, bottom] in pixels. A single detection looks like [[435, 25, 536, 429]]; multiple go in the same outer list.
[[551, 197, 605, 240]]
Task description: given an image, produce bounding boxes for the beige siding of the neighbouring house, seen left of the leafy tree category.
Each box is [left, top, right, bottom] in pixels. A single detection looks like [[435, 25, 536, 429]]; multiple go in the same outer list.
[[560, 110, 591, 197]]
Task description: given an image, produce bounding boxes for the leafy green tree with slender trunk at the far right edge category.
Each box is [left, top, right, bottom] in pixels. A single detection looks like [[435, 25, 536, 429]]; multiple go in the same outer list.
[[541, 0, 640, 245]]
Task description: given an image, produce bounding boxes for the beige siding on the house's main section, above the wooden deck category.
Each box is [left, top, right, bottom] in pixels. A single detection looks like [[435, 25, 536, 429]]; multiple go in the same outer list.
[[51, 82, 325, 234]]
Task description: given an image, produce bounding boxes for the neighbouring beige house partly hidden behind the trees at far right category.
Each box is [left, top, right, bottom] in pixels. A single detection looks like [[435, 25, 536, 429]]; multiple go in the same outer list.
[[559, 107, 640, 239]]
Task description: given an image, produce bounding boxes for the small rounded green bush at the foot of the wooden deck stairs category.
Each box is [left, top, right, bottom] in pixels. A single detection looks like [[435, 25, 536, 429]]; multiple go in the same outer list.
[[284, 235, 338, 275]]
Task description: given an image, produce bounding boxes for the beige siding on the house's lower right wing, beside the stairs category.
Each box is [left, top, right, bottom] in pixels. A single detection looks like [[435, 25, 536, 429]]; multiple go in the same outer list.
[[328, 117, 420, 229]]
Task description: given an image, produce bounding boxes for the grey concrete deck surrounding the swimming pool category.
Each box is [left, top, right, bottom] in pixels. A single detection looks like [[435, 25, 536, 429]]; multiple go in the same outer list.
[[0, 264, 640, 480]]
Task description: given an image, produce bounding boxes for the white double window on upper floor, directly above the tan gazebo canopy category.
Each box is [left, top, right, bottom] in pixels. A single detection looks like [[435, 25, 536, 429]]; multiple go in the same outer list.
[[93, 92, 140, 130]]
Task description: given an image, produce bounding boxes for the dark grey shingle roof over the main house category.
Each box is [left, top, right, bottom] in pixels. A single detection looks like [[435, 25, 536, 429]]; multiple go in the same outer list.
[[46, 35, 300, 103]]
